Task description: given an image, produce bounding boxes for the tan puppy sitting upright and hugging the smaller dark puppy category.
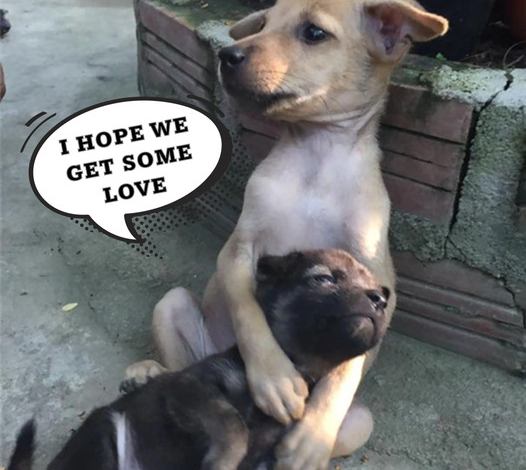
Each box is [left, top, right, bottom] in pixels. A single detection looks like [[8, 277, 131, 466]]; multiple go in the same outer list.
[[128, 0, 448, 470]]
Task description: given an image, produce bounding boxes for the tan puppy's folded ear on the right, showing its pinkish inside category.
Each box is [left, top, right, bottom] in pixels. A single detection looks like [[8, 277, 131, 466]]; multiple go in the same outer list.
[[365, 0, 449, 63]]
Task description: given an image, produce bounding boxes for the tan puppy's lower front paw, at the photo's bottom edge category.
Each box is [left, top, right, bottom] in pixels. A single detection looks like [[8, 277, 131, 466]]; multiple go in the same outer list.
[[274, 413, 338, 470]]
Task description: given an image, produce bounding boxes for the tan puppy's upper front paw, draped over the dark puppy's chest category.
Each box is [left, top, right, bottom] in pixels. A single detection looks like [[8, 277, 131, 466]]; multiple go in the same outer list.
[[247, 350, 309, 424]]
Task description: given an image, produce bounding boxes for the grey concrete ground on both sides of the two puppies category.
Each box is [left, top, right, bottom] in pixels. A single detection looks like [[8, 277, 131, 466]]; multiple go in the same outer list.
[[0, 0, 526, 470]]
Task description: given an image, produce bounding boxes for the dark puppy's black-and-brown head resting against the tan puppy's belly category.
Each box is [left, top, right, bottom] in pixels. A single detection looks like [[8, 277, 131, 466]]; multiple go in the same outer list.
[[256, 250, 389, 374]]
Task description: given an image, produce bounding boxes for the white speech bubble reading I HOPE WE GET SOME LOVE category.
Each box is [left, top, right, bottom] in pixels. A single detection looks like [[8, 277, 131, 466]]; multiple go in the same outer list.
[[29, 98, 232, 242]]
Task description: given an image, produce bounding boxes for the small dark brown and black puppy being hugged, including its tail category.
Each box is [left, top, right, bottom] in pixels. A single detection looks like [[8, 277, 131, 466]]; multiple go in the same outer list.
[[8, 250, 389, 470]]
